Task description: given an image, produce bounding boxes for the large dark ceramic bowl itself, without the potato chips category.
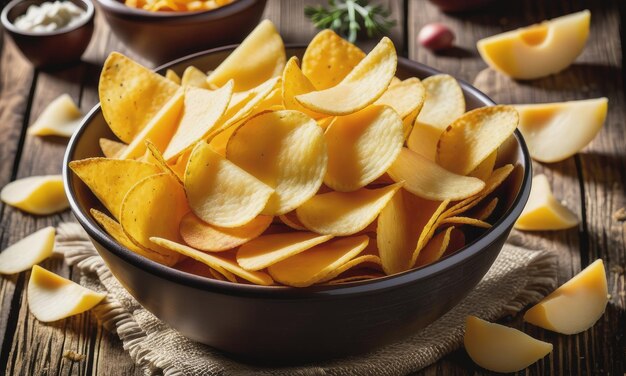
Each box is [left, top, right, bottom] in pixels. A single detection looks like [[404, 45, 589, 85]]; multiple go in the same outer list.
[[63, 46, 531, 363]]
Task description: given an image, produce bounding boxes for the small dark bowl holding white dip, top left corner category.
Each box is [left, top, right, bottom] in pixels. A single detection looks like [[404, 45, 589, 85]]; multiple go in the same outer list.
[[0, 0, 95, 67]]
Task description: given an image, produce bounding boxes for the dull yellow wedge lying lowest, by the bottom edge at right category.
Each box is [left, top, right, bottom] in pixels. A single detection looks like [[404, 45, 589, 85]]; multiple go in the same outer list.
[[463, 316, 552, 373]]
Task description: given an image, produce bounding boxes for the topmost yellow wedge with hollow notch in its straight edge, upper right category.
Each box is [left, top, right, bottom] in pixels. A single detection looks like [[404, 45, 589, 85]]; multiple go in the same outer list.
[[477, 10, 591, 80]]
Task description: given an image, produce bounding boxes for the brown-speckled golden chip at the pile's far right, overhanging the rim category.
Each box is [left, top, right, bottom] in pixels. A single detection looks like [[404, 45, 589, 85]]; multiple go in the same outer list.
[[437, 105, 519, 175]]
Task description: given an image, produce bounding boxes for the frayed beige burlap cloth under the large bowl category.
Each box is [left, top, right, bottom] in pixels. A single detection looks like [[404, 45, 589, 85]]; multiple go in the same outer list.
[[55, 223, 556, 376]]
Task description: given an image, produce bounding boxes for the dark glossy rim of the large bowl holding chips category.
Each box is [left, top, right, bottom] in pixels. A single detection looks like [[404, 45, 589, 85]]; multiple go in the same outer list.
[[63, 44, 532, 299]]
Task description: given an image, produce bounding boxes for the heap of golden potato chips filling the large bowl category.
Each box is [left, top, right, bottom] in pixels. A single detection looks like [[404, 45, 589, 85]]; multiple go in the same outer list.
[[70, 21, 518, 287]]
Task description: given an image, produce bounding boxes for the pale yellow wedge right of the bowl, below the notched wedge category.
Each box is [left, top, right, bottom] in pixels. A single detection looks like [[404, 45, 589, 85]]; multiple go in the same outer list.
[[514, 98, 608, 163]]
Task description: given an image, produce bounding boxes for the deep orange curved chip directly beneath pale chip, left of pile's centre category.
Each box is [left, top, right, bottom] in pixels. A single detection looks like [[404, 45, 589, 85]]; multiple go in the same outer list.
[[180, 213, 272, 252]]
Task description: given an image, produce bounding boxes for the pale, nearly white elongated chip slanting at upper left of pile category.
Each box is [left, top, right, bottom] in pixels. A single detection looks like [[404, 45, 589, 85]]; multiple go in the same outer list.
[[163, 81, 233, 161]]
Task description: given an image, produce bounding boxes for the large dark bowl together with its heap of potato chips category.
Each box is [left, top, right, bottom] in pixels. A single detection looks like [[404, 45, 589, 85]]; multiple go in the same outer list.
[[64, 21, 531, 363]]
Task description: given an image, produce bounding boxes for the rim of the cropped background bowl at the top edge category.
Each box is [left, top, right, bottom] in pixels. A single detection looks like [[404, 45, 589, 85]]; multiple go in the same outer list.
[[95, 0, 261, 22]]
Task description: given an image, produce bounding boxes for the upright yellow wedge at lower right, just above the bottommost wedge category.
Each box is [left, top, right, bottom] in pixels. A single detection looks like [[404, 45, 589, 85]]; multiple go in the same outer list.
[[524, 259, 609, 334]]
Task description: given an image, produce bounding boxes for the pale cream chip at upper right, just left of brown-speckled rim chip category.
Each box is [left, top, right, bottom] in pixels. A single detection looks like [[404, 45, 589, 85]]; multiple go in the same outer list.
[[417, 74, 465, 131]]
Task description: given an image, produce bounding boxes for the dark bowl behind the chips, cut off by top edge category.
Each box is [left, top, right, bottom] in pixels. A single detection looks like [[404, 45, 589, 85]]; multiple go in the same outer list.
[[97, 0, 266, 64]]
